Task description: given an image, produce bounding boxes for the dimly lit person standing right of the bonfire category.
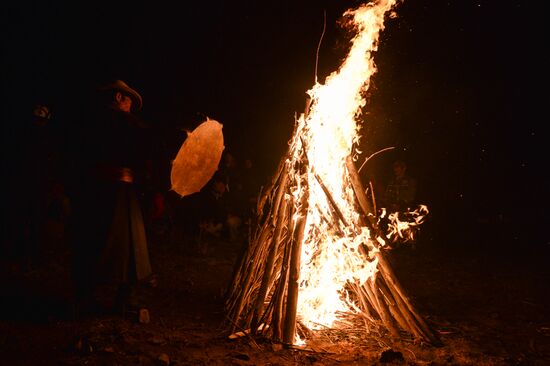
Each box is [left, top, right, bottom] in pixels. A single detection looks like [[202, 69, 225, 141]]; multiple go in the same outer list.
[[384, 160, 417, 212]]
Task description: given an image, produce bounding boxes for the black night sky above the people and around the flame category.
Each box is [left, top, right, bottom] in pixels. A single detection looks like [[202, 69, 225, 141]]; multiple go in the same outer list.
[[1, 0, 550, 249]]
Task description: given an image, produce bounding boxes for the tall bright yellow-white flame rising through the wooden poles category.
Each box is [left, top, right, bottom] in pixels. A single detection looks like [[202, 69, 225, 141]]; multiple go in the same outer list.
[[287, 0, 403, 329]]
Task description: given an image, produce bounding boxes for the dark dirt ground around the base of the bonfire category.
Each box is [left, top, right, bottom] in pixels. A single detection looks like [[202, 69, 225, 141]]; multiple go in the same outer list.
[[0, 219, 550, 366]]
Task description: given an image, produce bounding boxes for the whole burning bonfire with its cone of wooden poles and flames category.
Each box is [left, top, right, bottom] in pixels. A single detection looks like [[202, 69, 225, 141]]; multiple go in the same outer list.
[[226, 0, 439, 345]]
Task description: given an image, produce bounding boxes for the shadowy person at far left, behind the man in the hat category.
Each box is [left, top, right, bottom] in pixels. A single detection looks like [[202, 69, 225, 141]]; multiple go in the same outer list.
[[5, 104, 70, 270]]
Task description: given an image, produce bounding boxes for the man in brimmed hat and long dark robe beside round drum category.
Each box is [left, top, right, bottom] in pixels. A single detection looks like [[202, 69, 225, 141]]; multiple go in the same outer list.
[[68, 80, 165, 314]]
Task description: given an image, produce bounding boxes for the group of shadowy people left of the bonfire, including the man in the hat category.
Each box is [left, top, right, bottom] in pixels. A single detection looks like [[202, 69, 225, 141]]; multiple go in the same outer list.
[[0, 80, 259, 316]]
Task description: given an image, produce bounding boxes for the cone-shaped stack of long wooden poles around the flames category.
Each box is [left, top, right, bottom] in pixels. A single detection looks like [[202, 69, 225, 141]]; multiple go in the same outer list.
[[225, 118, 439, 345]]
